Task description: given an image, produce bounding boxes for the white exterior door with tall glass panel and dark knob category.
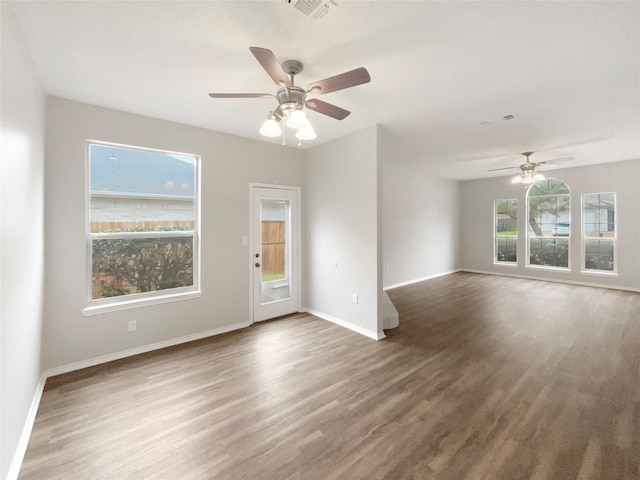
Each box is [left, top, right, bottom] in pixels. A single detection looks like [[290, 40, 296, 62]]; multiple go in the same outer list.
[[251, 186, 299, 322]]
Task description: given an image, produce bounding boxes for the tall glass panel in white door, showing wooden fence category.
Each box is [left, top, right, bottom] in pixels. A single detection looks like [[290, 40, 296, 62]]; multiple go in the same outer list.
[[260, 200, 291, 304]]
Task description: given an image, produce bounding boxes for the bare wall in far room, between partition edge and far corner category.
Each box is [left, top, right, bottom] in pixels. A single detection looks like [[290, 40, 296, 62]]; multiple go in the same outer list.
[[383, 154, 460, 288]]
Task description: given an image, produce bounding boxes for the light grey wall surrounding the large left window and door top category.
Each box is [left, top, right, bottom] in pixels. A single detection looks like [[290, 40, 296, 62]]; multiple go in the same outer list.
[[43, 98, 304, 369]]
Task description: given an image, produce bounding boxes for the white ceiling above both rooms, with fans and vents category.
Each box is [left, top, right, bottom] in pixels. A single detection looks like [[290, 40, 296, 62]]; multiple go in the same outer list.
[[15, 0, 640, 179]]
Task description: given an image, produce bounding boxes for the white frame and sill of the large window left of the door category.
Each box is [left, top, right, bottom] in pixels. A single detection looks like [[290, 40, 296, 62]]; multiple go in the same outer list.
[[82, 140, 202, 315]]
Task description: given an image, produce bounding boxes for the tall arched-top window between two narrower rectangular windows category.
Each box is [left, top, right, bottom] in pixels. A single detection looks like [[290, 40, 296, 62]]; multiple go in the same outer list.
[[527, 178, 571, 269]]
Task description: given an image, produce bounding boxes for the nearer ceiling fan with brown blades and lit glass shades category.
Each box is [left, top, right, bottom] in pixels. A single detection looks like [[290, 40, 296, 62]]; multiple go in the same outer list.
[[209, 47, 371, 144]]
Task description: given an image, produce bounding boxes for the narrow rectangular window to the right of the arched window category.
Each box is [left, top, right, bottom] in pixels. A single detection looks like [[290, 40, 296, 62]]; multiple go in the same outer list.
[[582, 193, 616, 273]]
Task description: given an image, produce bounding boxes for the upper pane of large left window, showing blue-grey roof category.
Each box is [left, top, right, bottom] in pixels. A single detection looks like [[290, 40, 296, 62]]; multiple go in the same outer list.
[[89, 144, 196, 233]]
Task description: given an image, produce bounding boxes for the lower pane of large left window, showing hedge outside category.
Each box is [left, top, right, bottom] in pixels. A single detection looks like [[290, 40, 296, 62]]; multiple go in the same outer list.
[[91, 237, 193, 300]]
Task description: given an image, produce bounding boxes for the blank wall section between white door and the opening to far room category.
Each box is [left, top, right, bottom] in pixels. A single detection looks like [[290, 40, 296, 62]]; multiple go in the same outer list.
[[303, 126, 383, 338]]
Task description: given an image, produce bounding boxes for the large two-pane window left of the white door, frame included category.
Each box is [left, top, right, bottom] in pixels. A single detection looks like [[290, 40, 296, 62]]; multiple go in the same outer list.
[[85, 142, 199, 313]]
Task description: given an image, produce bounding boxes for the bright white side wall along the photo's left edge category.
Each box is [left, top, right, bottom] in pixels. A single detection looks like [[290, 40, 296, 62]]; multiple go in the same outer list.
[[0, 2, 45, 479]]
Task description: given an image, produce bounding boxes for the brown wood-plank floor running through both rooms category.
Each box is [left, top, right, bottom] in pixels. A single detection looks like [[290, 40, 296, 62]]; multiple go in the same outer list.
[[19, 273, 640, 480]]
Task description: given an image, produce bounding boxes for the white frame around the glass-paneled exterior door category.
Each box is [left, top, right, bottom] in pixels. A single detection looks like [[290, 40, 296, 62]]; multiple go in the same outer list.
[[247, 182, 302, 325]]
